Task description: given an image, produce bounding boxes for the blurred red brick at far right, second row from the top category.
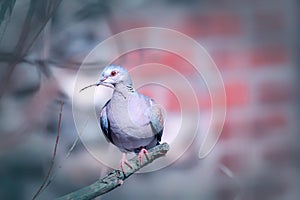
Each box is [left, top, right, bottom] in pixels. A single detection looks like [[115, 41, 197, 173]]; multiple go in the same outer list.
[[249, 46, 288, 67]]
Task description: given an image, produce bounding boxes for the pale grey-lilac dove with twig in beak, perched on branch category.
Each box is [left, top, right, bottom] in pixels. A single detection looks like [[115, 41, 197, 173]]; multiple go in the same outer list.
[[82, 65, 164, 172]]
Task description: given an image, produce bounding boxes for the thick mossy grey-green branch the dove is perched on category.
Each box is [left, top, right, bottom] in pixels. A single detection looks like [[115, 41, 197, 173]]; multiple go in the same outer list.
[[57, 143, 170, 200]]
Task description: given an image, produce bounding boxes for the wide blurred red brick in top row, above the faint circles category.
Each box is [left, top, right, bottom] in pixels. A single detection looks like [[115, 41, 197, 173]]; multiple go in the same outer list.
[[180, 12, 243, 37]]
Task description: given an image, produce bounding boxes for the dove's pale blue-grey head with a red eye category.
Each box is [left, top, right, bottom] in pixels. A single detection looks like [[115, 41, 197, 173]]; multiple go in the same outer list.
[[99, 65, 132, 86]]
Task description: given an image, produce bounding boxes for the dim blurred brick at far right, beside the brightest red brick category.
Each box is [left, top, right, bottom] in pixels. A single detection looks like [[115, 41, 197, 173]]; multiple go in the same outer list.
[[258, 81, 293, 105]]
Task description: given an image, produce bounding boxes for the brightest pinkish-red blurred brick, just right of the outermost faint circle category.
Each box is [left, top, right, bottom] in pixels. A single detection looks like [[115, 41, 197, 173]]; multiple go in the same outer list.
[[225, 81, 250, 107]]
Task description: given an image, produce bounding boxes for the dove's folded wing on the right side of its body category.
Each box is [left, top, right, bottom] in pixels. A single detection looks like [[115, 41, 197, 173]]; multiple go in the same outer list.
[[148, 99, 164, 142]]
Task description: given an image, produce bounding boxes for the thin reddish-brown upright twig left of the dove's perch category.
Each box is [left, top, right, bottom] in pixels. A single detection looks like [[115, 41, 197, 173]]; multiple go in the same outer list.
[[32, 102, 64, 200]]
